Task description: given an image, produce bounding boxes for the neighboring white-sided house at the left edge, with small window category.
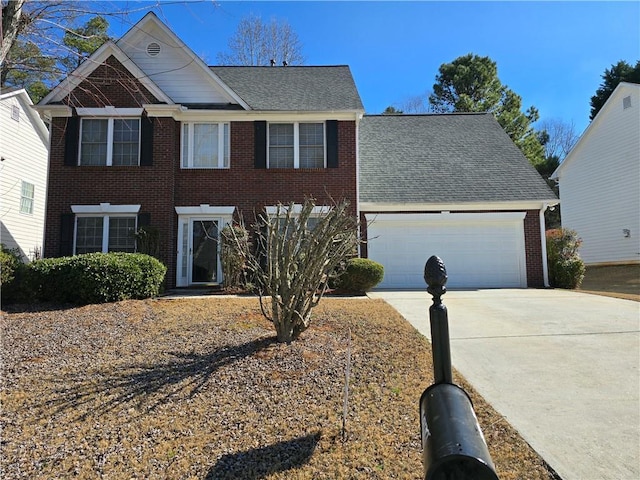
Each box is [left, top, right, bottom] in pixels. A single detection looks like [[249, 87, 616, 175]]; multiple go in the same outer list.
[[0, 89, 49, 260]]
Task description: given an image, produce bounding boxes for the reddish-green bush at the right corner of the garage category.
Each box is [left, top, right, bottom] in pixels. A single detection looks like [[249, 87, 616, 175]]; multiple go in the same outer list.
[[546, 228, 585, 289]]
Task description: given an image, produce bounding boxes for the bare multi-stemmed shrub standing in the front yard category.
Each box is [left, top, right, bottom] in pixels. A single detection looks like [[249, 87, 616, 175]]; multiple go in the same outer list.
[[235, 199, 359, 343]]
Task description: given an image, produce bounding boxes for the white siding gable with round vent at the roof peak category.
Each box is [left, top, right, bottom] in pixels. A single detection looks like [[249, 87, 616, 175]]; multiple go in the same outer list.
[[117, 15, 238, 104]]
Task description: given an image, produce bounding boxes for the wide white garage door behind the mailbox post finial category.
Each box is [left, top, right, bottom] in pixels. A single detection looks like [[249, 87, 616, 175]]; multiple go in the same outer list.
[[366, 212, 527, 288]]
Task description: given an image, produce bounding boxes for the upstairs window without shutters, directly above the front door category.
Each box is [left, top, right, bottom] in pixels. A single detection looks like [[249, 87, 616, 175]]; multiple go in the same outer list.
[[182, 123, 229, 168]]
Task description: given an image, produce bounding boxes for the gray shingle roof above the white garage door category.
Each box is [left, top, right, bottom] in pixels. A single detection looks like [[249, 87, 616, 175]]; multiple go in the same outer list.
[[360, 114, 556, 203]]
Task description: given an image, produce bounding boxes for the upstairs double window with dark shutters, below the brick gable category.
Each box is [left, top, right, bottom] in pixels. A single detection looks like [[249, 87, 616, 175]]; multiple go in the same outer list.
[[80, 118, 140, 166]]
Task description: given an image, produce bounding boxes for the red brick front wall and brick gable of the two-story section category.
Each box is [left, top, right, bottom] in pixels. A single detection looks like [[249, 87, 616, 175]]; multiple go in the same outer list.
[[44, 57, 356, 287]]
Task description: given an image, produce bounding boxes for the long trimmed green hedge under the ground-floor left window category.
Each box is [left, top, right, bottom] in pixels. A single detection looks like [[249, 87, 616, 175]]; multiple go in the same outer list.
[[27, 252, 167, 305]]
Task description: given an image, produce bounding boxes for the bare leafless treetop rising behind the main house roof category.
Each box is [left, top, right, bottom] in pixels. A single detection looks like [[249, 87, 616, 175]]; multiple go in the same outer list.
[[217, 15, 304, 66]]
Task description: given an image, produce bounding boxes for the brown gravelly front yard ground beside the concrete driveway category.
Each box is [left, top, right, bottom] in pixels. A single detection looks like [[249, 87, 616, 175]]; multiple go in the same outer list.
[[0, 297, 554, 480]]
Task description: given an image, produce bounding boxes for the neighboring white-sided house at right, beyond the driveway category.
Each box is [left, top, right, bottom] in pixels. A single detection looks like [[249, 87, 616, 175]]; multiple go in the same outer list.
[[551, 83, 640, 265]]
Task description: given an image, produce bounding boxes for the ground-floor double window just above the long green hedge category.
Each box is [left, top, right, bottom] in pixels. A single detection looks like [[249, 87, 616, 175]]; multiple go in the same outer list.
[[75, 215, 136, 254]]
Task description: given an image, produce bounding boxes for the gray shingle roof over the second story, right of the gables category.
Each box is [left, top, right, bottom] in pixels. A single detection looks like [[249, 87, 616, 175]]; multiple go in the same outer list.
[[210, 65, 364, 111]]
